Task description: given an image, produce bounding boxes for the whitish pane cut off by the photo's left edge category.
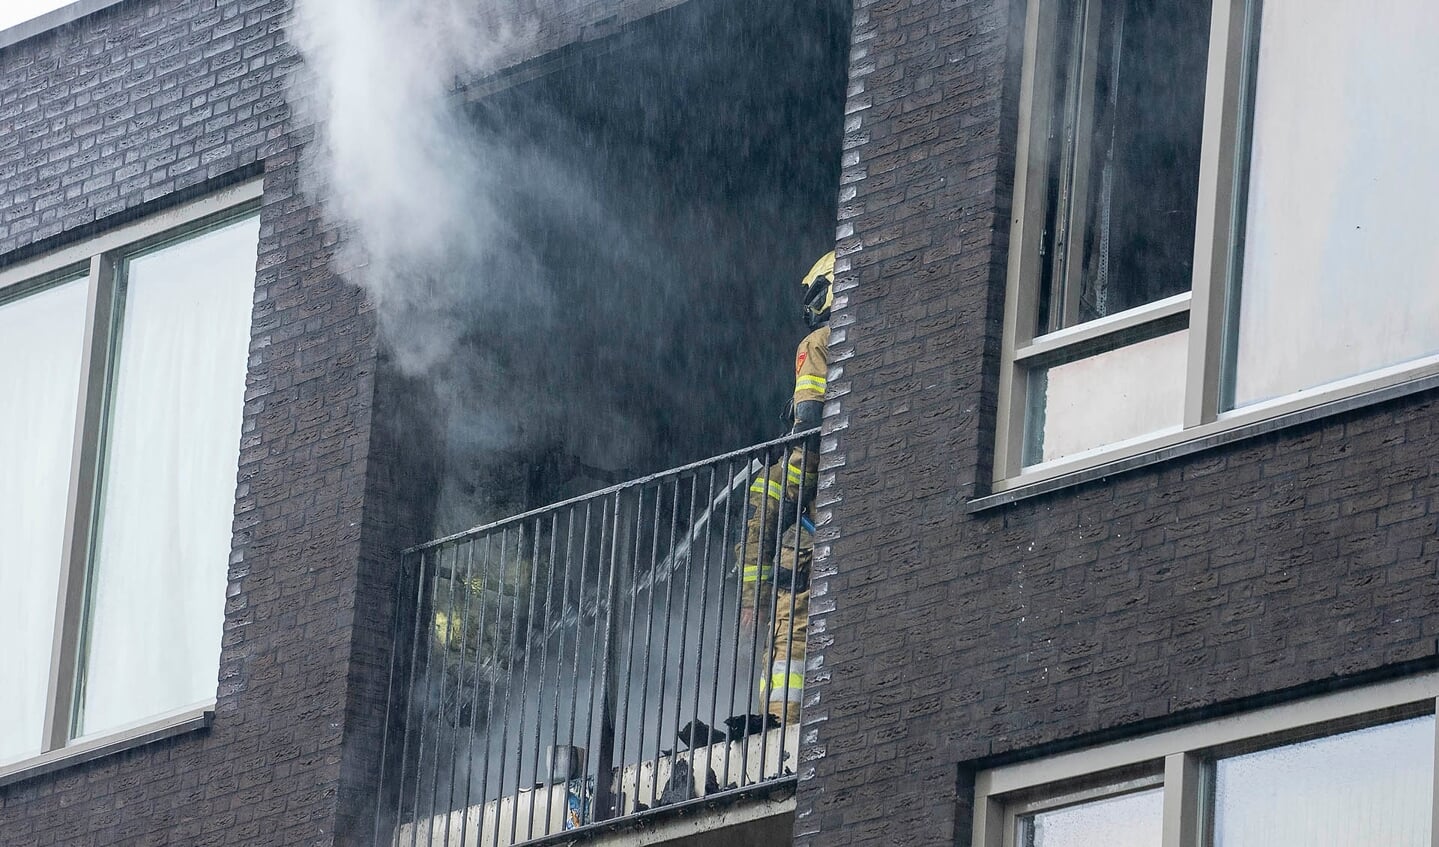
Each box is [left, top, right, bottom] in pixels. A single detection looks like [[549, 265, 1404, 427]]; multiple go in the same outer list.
[[0, 279, 85, 762]]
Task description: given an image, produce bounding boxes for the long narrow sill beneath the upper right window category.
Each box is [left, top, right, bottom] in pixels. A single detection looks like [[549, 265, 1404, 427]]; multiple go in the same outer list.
[[966, 364, 1439, 515]]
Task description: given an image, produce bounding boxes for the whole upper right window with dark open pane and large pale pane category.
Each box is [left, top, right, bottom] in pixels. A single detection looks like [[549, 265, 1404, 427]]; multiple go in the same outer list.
[[994, 0, 1439, 492]]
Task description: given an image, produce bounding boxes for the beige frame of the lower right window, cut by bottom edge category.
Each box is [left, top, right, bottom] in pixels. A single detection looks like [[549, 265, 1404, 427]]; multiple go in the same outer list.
[[970, 672, 1439, 847]]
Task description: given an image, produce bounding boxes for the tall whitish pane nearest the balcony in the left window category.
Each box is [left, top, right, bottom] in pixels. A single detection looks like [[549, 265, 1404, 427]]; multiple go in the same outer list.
[[75, 217, 259, 735]]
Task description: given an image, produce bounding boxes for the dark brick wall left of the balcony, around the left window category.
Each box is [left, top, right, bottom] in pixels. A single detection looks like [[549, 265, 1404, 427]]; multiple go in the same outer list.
[[0, 0, 389, 847]]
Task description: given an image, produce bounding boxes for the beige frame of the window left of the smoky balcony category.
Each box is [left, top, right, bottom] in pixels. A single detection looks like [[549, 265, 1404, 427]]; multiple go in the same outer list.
[[0, 178, 263, 785]]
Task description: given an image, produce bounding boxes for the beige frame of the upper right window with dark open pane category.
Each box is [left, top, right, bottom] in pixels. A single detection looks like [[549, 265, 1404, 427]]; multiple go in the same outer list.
[[995, 0, 1439, 491]]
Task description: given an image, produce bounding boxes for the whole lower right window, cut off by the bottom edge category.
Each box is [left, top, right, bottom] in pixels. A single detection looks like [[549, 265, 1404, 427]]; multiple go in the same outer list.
[[973, 673, 1439, 847]]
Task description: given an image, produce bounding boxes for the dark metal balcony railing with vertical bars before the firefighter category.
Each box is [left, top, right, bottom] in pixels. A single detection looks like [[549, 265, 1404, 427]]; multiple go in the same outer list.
[[376, 433, 817, 847]]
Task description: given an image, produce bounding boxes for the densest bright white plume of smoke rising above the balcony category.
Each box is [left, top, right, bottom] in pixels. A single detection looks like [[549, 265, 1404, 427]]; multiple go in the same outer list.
[[291, 0, 535, 374]]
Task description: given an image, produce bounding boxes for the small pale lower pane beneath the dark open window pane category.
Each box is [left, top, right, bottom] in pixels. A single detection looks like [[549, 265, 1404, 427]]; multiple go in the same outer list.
[[1025, 329, 1189, 466]]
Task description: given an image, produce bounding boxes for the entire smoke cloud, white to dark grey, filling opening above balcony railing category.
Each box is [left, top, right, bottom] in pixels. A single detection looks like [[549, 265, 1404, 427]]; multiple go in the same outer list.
[[288, 0, 842, 535]]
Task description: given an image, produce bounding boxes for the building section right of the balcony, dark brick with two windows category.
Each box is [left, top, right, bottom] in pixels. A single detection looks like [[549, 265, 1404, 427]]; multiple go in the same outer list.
[[796, 0, 1436, 846]]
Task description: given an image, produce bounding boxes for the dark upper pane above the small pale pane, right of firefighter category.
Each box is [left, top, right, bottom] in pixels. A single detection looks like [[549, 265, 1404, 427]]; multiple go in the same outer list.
[[1038, 0, 1209, 334]]
